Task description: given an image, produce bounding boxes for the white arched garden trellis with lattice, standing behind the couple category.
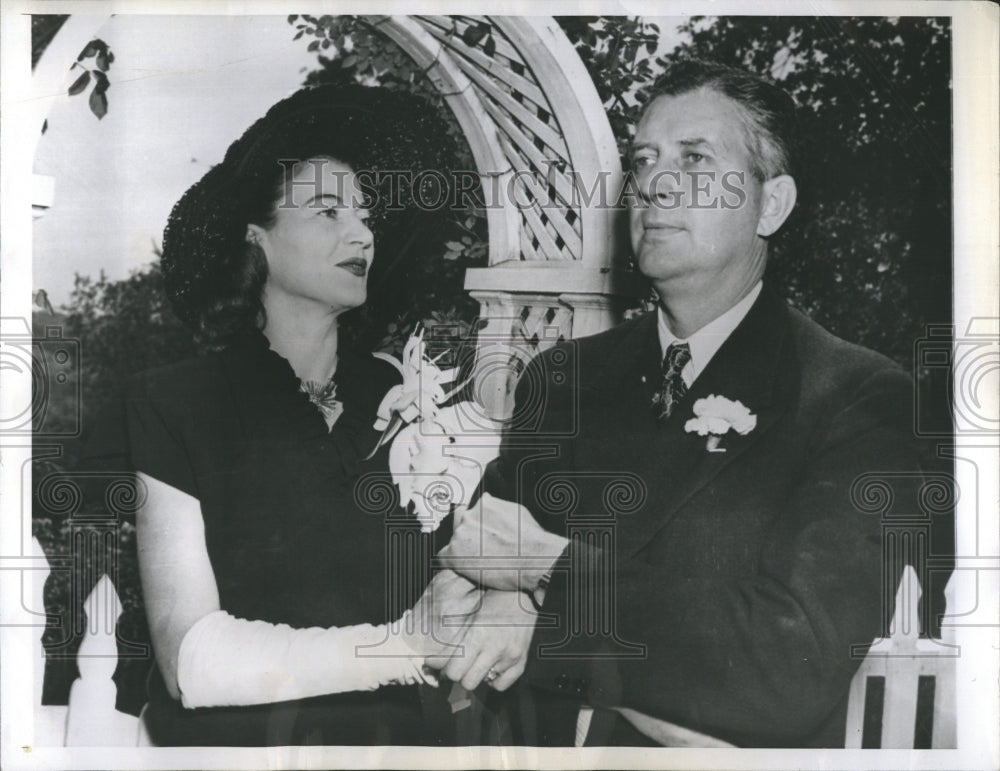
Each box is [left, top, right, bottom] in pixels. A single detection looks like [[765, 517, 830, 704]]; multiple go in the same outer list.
[[35, 16, 643, 415]]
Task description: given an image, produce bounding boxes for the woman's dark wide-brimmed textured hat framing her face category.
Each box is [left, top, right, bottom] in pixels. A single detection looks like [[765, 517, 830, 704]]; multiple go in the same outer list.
[[161, 85, 454, 350]]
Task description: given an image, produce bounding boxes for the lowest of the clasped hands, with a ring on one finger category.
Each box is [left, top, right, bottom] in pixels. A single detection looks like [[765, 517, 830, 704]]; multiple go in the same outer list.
[[426, 589, 538, 691]]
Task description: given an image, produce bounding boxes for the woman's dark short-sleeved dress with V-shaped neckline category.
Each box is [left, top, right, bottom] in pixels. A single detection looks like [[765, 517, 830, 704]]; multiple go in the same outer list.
[[126, 335, 437, 746]]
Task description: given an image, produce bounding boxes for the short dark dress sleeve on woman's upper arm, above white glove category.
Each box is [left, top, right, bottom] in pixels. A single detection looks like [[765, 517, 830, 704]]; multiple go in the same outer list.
[[125, 376, 199, 498]]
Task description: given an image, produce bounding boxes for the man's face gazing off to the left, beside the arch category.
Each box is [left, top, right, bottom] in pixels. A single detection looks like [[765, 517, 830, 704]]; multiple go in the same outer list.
[[629, 88, 765, 288]]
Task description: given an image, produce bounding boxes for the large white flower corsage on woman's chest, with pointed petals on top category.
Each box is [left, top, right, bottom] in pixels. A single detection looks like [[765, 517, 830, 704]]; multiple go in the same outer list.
[[369, 330, 500, 532]]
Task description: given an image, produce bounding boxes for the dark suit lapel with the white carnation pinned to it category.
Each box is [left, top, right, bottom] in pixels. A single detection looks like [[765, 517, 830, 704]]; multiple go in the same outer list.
[[604, 287, 798, 556]]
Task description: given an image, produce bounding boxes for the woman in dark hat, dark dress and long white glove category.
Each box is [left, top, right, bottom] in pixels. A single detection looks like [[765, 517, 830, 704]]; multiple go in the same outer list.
[[126, 87, 477, 745]]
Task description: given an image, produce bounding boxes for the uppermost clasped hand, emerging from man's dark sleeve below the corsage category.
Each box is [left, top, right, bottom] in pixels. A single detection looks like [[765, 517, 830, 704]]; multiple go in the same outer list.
[[438, 493, 569, 592]]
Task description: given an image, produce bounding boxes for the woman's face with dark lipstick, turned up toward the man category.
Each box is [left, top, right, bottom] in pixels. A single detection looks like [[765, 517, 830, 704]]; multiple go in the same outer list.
[[247, 158, 373, 314]]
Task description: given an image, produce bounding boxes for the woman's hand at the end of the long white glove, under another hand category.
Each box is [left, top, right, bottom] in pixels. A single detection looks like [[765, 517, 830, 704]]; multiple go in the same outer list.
[[389, 570, 483, 658]]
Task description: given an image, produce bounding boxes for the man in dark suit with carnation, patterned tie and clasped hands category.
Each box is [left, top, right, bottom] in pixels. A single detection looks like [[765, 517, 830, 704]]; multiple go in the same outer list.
[[434, 62, 918, 747]]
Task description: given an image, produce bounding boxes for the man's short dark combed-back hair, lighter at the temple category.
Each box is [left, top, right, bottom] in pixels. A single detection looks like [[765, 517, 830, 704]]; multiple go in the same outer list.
[[646, 59, 796, 181]]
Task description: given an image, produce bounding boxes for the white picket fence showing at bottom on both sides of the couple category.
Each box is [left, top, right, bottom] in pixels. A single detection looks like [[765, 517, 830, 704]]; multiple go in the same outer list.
[[34, 539, 956, 749]]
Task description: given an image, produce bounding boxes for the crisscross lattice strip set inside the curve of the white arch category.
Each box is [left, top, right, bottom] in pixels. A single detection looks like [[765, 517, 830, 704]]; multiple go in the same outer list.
[[415, 16, 583, 261]]
